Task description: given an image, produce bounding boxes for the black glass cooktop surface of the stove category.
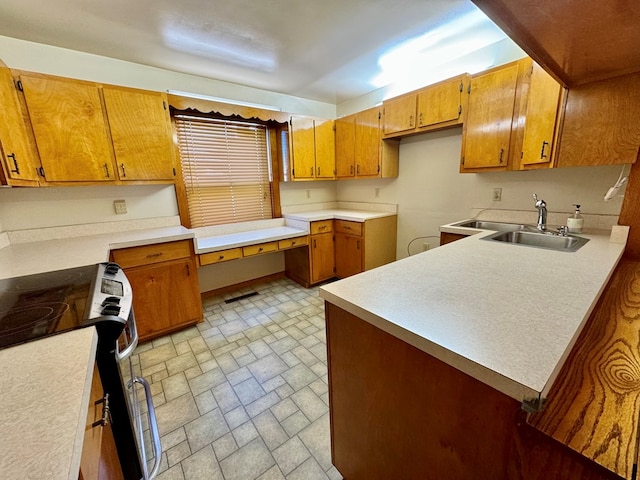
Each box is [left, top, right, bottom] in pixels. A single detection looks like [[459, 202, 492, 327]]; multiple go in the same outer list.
[[0, 265, 98, 348]]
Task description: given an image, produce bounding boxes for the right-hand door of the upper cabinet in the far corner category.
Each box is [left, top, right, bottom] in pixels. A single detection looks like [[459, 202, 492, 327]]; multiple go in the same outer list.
[[355, 108, 382, 177]]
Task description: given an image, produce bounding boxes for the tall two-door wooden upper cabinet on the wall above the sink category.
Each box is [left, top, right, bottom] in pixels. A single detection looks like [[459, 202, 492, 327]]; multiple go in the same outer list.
[[460, 58, 563, 172]]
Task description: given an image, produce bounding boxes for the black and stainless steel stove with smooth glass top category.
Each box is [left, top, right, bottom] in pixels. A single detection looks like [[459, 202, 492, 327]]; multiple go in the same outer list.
[[0, 262, 161, 480]]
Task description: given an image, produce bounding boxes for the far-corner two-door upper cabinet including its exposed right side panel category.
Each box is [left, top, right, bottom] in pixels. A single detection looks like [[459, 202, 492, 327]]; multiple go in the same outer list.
[[335, 107, 399, 179]]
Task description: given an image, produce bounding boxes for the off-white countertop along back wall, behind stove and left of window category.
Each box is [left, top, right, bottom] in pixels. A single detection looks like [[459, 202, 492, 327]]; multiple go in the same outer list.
[[0, 226, 194, 279]]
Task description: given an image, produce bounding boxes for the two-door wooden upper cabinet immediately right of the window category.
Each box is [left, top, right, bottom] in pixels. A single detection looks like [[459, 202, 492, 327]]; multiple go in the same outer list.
[[289, 117, 336, 180]]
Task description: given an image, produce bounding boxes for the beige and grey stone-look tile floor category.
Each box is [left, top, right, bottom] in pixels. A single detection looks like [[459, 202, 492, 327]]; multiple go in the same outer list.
[[132, 279, 342, 480]]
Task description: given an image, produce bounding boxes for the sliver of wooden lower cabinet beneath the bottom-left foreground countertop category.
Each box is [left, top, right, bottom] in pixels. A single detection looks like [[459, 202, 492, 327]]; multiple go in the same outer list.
[[78, 365, 124, 480]]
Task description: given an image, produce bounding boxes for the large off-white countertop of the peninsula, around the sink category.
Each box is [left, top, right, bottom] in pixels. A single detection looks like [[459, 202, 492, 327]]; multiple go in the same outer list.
[[320, 230, 624, 401]]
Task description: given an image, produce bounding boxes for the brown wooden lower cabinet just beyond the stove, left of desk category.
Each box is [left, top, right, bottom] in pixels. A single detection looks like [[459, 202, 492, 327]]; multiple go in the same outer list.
[[111, 240, 202, 341]]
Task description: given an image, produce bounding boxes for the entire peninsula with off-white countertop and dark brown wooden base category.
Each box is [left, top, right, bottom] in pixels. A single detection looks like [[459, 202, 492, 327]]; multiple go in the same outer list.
[[321, 231, 635, 480]]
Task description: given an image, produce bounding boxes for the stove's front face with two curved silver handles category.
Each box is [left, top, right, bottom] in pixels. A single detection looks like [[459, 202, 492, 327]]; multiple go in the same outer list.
[[116, 310, 162, 480]]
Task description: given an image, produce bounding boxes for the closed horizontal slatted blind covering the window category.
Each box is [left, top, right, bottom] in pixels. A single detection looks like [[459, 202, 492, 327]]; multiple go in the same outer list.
[[174, 114, 273, 227]]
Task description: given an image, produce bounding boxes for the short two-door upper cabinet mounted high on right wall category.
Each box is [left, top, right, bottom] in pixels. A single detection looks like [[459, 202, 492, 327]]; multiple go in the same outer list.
[[383, 73, 471, 138]]
